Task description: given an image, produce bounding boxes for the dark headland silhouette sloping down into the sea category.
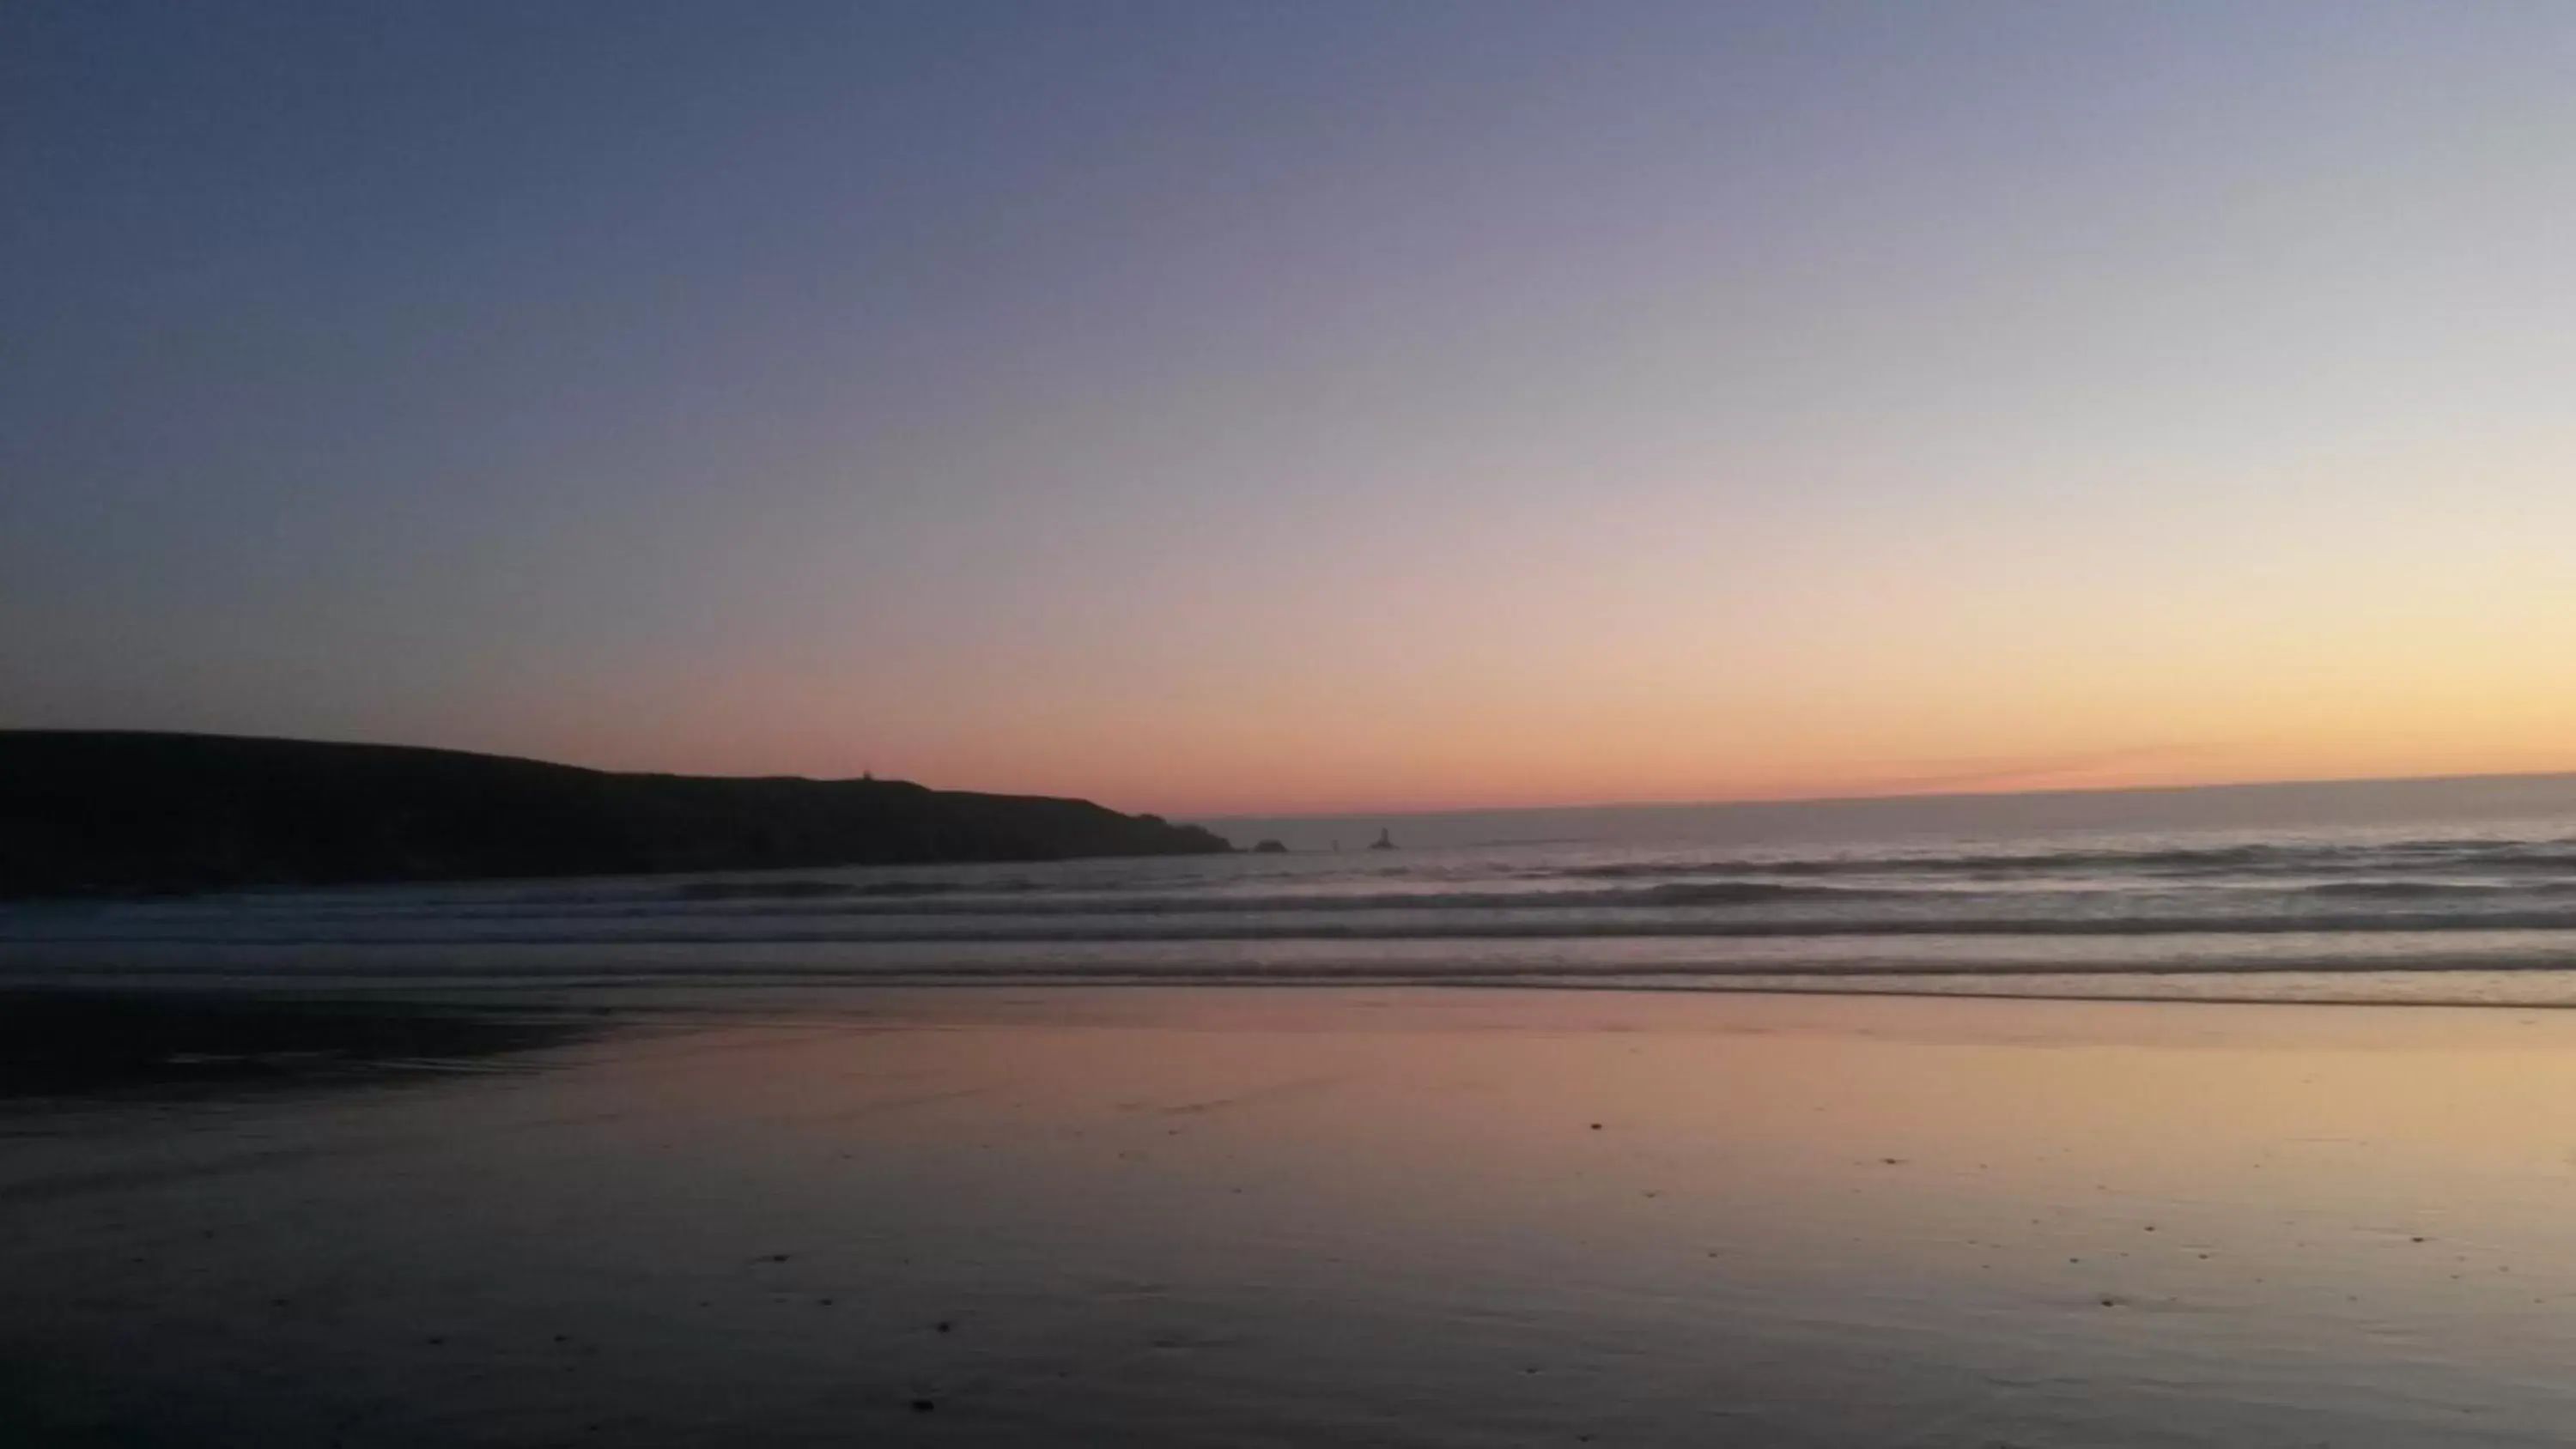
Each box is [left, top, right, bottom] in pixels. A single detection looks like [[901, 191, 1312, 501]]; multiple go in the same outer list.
[[0, 731, 1231, 895]]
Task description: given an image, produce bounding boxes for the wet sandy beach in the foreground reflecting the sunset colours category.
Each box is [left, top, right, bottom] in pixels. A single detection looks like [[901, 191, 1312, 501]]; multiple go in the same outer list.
[[0, 988, 2576, 1446]]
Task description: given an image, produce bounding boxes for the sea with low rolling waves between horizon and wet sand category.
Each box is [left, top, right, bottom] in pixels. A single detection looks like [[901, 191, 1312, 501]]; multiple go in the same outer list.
[[15, 777, 2576, 1006]]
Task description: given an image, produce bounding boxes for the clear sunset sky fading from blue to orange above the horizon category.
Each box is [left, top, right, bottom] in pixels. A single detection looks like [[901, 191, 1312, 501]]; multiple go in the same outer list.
[[0, 0, 2576, 815]]
